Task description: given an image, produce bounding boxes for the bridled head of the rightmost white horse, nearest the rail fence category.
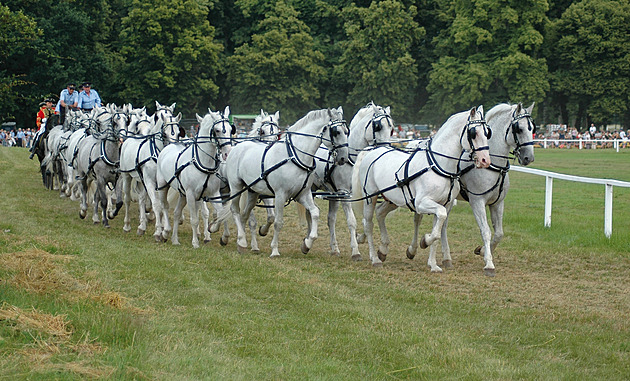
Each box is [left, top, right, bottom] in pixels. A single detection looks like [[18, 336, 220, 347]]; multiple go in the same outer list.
[[505, 103, 536, 165]]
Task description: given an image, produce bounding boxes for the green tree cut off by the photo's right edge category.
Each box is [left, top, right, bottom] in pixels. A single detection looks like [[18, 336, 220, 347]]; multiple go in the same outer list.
[[549, 0, 630, 127]]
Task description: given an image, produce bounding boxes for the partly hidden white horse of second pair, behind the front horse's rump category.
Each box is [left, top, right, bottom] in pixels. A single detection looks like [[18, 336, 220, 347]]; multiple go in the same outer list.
[[313, 102, 394, 261]]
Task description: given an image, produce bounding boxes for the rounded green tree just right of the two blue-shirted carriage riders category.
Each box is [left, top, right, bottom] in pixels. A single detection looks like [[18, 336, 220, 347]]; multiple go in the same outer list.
[[118, 0, 222, 115]]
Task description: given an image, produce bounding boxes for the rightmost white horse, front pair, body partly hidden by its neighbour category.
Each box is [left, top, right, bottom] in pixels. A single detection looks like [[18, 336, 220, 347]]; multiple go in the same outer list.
[[431, 103, 536, 276]]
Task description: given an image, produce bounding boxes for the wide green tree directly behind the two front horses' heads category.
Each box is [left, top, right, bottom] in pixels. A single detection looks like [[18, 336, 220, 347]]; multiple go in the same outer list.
[[425, 0, 549, 121]]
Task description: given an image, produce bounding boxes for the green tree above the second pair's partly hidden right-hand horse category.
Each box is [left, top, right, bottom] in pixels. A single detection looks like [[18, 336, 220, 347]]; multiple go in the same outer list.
[[335, 0, 425, 118]]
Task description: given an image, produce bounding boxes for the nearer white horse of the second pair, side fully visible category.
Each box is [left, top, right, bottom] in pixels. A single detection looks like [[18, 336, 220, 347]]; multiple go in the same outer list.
[[219, 107, 348, 257]]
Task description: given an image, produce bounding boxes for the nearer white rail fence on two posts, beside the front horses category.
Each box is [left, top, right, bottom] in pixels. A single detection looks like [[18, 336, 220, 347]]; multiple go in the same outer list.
[[510, 165, 630, 238]]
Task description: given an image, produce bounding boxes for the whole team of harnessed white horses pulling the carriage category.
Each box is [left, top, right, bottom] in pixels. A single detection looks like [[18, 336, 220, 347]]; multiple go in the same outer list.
[[37, 102, 535, 276]]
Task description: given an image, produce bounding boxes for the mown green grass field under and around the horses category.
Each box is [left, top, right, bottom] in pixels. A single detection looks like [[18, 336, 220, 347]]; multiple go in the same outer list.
[[0, 147, 630, 380]]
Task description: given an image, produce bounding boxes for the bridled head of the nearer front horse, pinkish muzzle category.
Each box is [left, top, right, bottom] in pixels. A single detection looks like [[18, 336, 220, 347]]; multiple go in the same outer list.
[[460, 105, 492, 168]]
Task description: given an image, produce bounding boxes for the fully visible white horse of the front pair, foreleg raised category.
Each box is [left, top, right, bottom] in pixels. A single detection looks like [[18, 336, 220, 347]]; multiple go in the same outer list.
[[353, 106, 491, 272]]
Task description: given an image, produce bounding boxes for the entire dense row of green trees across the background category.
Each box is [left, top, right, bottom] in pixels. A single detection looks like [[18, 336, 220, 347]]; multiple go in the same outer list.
[[0, 0, 630, 128]]
